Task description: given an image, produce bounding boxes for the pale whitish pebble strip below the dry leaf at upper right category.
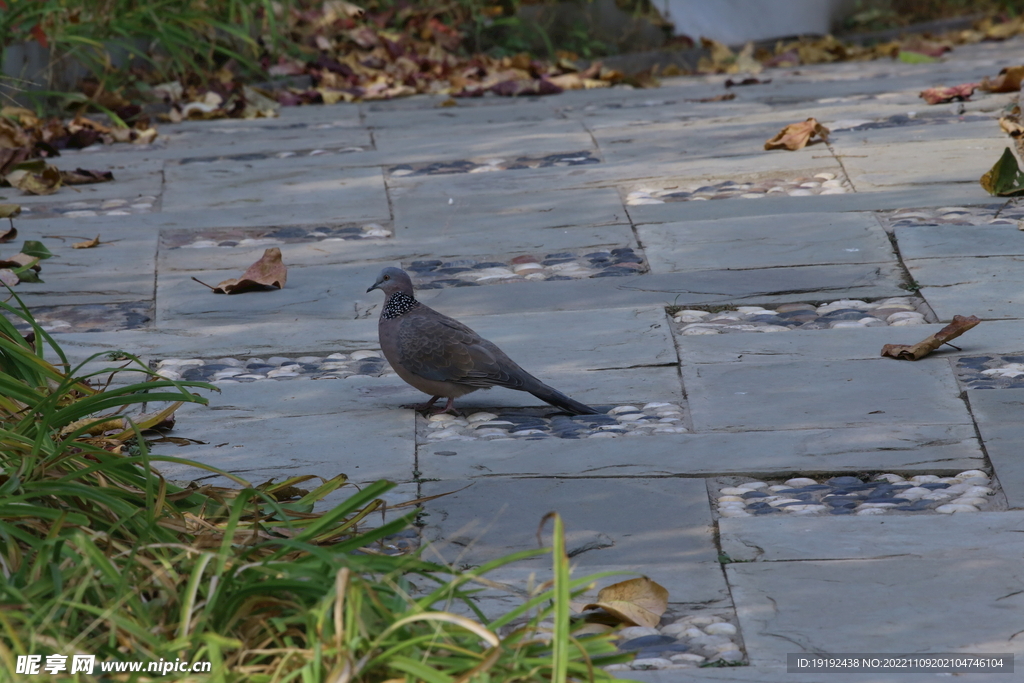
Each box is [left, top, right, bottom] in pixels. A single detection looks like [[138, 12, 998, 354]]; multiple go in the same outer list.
[[626, 173, 852, 206]]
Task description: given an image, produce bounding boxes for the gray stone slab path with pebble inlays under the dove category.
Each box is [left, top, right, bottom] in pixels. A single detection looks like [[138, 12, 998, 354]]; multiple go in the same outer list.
[[6, 36, 1024, 683]]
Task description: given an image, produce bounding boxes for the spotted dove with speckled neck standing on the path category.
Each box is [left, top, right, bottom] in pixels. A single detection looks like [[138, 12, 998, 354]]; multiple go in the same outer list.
[[367, 268, 597, 415]]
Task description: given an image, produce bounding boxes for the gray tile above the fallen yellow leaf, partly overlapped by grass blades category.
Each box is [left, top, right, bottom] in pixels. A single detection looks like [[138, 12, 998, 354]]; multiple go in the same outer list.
[[421, 479, 727, 602]]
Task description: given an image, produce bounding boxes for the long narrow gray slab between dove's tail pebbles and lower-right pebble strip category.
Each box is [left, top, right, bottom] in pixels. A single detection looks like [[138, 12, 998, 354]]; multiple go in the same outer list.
[[419, 425, 985, 481]]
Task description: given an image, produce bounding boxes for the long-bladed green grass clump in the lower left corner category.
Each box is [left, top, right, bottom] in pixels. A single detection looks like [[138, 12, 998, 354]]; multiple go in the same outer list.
[[0, 304, 628, 683]]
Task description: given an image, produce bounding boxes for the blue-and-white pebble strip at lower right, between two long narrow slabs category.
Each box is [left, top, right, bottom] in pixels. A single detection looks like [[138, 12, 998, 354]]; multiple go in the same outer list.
[[718, 470, 994, 517]]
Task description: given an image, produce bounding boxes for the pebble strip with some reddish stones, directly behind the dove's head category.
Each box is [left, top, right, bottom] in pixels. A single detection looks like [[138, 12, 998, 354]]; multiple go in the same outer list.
[[404, 247, 647, 290]]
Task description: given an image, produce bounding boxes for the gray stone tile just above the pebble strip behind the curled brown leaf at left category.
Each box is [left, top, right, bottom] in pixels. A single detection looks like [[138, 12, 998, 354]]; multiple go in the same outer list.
[[163, 157, 390, 221]]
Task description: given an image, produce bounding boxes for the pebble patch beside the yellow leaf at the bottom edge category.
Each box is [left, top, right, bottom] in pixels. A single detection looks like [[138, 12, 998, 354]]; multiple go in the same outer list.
[[605, 612, 745, 671]]
